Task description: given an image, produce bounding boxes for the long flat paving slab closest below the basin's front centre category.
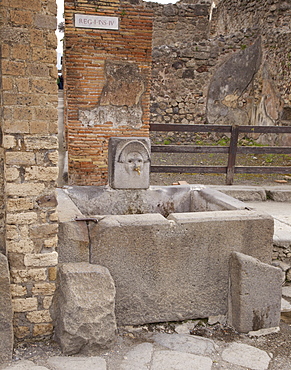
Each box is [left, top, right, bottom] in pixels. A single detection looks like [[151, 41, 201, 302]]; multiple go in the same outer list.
[[153, 333, 216, 355]]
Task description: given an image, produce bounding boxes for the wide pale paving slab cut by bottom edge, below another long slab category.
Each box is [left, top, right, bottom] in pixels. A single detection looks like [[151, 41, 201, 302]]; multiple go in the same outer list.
[[152, 351, 212, 370]]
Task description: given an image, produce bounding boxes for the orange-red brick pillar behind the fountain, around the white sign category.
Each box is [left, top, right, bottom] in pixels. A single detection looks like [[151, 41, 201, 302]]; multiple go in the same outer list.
[[64, 0, 152, 185]]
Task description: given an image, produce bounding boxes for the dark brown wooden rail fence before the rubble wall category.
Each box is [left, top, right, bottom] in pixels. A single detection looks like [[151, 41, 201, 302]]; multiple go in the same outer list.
[[150, 123, 291, 185]]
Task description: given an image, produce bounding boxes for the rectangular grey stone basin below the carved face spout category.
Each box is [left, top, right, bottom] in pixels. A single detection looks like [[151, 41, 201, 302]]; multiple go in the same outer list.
[[59, 185, 273, 325]]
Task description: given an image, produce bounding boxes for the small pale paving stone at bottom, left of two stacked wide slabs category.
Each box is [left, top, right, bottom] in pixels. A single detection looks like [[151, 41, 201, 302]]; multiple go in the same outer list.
[[121, 343, 153, 370]]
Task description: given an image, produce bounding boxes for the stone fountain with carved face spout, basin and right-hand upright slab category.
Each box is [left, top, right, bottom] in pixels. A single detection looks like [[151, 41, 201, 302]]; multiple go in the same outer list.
[[55, 138, 281, 354]]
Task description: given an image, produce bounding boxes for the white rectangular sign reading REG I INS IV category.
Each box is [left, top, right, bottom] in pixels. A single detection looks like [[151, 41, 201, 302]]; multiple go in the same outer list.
[[75, 14, 119, 30]]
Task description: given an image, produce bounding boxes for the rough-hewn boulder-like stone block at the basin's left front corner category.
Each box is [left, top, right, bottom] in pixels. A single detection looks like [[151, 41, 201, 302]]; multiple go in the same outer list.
[[50, 262, 116, 355]]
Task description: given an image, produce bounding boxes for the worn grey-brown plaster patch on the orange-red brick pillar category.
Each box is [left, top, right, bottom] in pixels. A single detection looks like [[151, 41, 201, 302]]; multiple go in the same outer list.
[[79, 61, 145, 129]]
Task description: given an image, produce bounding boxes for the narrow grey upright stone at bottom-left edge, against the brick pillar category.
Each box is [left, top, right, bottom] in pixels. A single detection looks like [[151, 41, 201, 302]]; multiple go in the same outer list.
[[0, 253, 13, 364]]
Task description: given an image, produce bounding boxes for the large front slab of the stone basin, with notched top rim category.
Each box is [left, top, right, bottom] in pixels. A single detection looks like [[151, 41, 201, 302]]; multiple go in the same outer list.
[[90, 210, 273, 325]]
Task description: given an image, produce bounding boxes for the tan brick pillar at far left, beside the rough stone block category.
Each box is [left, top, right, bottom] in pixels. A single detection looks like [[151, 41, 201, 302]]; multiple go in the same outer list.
[[0, 0, 58, 339]]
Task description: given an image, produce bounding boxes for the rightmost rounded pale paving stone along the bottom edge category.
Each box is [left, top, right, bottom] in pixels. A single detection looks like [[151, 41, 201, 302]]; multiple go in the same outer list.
[[222, 343, 271, 370]]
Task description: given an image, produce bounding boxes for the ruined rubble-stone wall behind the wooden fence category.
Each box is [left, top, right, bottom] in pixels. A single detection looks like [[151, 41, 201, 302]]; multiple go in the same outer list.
[[148, 0, 291, 132]]
